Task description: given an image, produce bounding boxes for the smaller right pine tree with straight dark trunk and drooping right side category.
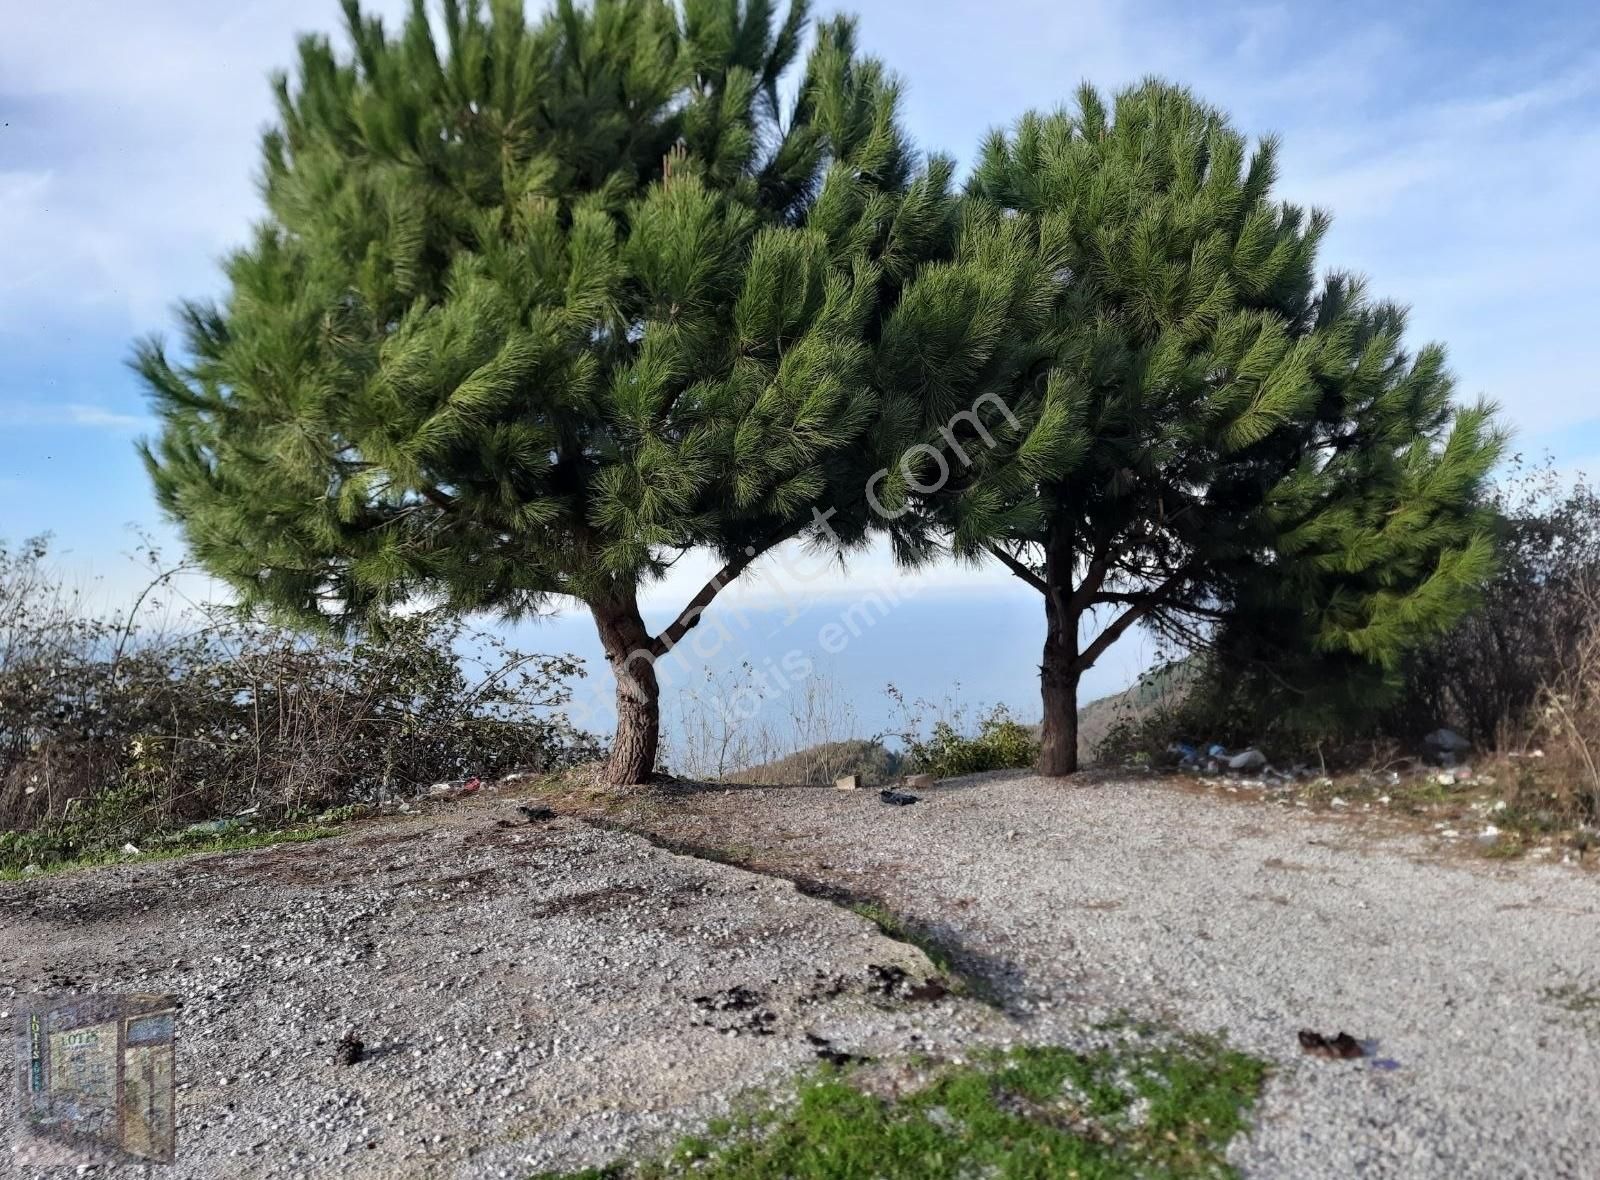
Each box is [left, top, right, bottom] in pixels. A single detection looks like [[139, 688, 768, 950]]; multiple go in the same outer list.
[[878, 82, 1501, 774]]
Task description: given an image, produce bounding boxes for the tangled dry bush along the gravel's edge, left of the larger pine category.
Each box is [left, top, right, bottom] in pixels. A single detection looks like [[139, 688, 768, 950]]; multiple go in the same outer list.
[[0, 540, 597, 862]]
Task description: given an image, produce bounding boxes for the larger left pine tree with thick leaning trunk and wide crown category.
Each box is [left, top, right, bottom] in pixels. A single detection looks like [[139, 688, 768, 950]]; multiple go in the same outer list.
[[136, 0, 955, 783]]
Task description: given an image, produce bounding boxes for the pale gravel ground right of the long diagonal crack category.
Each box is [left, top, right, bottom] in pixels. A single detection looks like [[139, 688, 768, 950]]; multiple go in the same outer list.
[[614, 772, 1600, 1178]]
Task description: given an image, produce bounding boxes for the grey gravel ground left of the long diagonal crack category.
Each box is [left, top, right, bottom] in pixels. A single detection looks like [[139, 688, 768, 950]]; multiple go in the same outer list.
[[0, 799, 1005, 1180]]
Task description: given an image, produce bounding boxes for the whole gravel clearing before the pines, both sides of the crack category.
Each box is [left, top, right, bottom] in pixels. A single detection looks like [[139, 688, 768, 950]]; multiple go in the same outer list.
[[12, 774, 1600, 1178]]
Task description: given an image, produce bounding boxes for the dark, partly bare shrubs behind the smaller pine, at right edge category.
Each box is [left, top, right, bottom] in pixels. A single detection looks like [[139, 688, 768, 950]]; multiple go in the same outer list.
[[1099, 460, 1600, 769]]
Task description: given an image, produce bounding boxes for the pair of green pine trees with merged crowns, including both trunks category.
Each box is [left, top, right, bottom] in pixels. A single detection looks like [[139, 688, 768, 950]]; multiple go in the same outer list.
[[136, 9, 1501, 782]]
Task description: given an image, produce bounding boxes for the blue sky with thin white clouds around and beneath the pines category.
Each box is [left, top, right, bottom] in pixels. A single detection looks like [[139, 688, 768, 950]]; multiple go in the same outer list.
[[0, 0, 1600, 754]]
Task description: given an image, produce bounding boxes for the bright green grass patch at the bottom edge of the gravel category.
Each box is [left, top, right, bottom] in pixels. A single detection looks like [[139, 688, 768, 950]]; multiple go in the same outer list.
[[536, 1038, 1266, 1180]]
